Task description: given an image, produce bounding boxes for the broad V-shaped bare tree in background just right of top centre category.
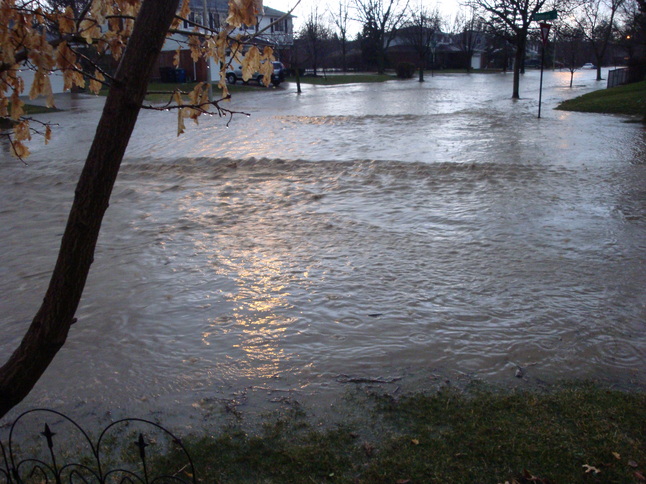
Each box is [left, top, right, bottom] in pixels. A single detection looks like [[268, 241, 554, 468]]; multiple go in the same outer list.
[[353, 0, 408, 74]]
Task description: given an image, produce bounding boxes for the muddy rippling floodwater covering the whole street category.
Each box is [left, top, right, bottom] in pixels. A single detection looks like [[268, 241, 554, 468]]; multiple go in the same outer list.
[[0, 71, 646, 424]]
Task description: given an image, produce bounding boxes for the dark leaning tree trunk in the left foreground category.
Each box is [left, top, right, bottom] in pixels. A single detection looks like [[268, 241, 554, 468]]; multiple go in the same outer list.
[[0, 0, 179, 417]]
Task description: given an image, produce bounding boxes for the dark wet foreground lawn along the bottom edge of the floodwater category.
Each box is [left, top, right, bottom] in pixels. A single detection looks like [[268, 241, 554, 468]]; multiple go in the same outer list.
[[157, 384, 646, 484]]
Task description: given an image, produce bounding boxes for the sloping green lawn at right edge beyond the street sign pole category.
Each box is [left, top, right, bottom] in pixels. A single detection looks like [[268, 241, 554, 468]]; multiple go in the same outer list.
[[556, 81, 646, 116]]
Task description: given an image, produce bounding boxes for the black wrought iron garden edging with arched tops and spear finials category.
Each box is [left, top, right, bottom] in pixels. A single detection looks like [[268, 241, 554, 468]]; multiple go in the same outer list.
[[0, 409, 197, 484]]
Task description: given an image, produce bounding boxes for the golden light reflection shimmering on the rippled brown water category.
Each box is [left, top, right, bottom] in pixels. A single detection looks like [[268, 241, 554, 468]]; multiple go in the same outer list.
[[179, 186, 296, 378]]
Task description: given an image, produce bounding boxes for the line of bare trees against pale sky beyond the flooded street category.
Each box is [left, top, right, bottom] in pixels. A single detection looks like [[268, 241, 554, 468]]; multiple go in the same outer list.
[[294, 0, 646, 98]]
